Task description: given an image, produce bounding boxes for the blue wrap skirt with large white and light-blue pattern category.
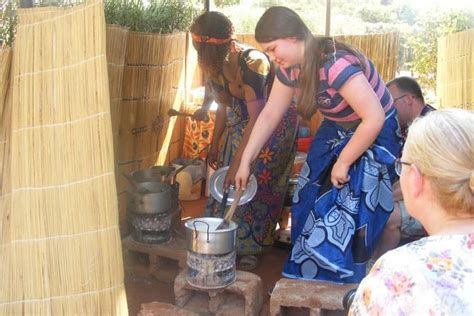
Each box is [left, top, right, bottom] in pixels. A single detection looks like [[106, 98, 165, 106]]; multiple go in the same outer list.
[[283, 109, 401, 283]]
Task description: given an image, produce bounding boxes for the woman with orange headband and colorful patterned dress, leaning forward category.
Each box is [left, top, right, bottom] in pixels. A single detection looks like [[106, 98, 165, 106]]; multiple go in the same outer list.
[[191, 12, 297, 268]]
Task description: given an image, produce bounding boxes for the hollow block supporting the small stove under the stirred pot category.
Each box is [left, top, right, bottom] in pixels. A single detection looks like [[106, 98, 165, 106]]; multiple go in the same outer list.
[[174, 270, 264, 316]]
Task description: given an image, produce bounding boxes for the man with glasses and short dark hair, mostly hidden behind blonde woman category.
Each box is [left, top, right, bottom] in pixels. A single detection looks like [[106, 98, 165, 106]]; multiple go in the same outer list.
[[373, 77, 435, 259]]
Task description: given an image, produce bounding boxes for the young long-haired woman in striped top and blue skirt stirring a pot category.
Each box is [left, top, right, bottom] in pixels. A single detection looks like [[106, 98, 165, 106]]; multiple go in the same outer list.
[[235, 7, 401, 283]]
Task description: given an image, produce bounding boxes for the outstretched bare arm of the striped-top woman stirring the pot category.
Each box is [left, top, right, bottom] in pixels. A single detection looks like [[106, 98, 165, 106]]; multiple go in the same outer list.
[[235, 77, 294, 190]]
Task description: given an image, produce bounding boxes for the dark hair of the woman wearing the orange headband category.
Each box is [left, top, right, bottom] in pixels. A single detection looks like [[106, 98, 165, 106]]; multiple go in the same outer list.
[[191, 11, 234, 77]]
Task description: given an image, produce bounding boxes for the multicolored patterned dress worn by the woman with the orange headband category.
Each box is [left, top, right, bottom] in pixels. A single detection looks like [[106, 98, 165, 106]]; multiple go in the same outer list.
[[206, 49, 298, 255]]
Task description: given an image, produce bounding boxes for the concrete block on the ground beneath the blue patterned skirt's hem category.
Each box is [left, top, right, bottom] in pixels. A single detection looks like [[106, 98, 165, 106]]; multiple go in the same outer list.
[[270, 279, 358, 316]]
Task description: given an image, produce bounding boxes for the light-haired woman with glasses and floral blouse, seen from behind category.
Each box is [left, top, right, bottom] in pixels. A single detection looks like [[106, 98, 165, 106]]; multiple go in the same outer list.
[[349, 109, 474, 315]]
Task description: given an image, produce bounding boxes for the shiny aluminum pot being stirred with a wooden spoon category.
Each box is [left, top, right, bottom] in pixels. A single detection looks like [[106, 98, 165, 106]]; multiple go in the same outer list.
[[184, 217, 237, 255]]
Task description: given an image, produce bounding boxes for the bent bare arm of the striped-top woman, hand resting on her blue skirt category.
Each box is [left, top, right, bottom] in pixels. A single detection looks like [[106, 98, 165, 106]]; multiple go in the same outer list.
[[331, 74, 385, 188]]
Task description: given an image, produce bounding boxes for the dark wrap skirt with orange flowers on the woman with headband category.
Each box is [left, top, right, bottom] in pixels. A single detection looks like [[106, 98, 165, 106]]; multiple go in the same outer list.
[[206, 98, 298, 255]]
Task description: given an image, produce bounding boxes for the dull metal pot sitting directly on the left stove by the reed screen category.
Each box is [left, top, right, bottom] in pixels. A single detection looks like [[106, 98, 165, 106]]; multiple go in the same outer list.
[[127, 182, 172, 214]]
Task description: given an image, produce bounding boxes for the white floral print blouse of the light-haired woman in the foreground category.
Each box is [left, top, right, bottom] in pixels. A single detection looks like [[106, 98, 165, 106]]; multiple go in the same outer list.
[[349, 233, 474, 316]]
